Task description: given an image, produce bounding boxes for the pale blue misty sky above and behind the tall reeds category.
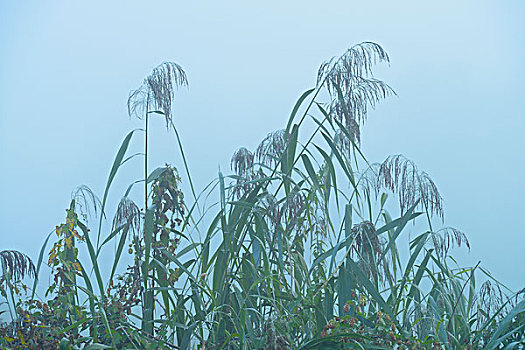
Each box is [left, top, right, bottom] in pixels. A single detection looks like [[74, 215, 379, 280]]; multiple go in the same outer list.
[[0, 0, 525, 289]]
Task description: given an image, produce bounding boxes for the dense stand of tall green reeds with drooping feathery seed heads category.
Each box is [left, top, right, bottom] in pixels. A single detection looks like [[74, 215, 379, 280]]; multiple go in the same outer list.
[[0, 42, 525, 350]]
